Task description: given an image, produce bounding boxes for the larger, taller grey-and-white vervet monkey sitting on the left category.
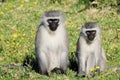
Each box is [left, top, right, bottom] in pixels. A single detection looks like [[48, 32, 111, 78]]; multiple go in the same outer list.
[[35, 10, 69, 75]]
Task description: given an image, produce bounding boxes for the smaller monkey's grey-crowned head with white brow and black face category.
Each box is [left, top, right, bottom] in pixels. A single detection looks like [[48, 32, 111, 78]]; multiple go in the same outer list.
[[81, 22, 101, 42]]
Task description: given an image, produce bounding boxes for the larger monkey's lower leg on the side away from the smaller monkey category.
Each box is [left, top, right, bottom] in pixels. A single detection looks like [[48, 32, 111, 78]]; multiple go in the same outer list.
[[37, 53, 49, 75]]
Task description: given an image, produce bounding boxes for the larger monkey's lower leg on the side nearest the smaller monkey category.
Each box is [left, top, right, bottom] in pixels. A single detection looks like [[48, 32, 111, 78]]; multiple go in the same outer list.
[[60, 52, 69, 74]]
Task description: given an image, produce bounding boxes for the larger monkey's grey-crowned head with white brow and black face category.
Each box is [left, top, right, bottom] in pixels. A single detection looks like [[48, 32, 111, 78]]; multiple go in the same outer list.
[[42, 10, 64, 31]]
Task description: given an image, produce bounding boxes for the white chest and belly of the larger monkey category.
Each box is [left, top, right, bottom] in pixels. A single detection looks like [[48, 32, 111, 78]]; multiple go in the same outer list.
[[41, 35, 65, 71]]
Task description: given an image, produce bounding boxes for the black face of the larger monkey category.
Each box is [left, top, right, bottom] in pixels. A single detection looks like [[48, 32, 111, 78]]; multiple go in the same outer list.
[[47, 19, 59, 31]]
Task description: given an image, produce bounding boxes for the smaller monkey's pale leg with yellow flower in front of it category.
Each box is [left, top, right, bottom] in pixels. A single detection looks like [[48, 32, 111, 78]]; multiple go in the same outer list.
[[86, 54, 96, 77]]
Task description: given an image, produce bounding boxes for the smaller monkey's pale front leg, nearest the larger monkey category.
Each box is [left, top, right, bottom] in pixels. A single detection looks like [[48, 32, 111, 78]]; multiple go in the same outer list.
[[77, 56, 86, 77]]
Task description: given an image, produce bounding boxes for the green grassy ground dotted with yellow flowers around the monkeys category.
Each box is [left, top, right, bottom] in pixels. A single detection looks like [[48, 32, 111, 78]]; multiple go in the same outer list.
[[0, 0, 120, 80]]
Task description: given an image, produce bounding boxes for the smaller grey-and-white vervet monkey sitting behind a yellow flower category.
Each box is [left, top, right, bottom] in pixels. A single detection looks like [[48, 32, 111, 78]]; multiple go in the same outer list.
[[76, 22, 106, 77]]
